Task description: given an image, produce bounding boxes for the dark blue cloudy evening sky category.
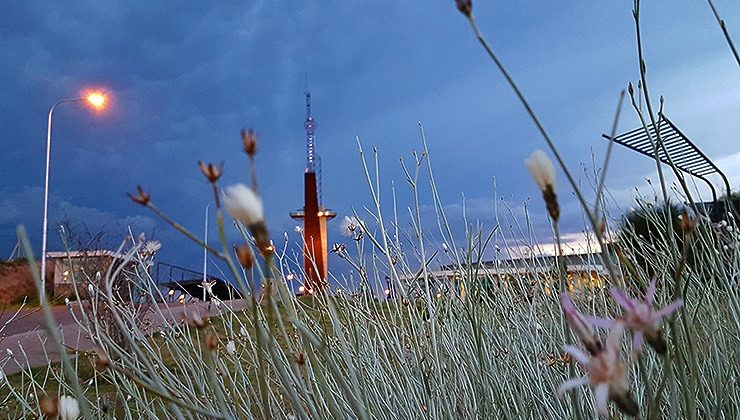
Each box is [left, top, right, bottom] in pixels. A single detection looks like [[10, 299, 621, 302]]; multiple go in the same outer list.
[[0, 0, 740, 284]]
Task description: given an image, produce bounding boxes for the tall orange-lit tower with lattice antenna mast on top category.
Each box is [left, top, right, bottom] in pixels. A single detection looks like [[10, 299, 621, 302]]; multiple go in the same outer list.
[[290, 89, 337, 293]]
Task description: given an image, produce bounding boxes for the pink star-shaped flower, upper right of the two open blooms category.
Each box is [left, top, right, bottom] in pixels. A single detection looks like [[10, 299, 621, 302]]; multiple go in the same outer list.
[[610, 279, 683, 354]]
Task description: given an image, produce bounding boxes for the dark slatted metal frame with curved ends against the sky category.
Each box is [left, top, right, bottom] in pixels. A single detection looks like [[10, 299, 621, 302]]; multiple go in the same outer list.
[[601, 113, 732, 206]]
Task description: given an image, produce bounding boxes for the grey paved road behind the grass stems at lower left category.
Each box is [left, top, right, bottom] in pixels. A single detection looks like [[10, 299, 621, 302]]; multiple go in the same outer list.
[[0, 299, 245, 375]]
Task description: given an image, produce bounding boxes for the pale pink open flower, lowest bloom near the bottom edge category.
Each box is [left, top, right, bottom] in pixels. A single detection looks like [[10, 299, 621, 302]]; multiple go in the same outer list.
[[557, 323, 638, 416]]
